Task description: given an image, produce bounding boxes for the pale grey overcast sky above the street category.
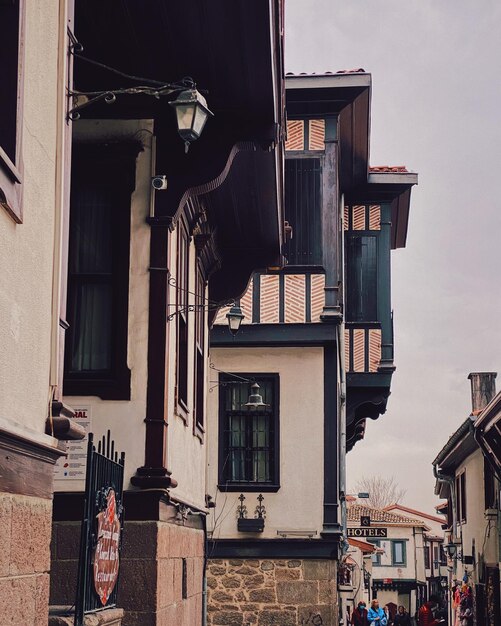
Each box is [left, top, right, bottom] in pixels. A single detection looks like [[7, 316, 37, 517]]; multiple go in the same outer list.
[[286, 0, 501, 512]]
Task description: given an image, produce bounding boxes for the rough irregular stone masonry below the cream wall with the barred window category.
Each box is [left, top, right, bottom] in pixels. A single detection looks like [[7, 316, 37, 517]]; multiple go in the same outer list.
[[207, 559, 338, 626]]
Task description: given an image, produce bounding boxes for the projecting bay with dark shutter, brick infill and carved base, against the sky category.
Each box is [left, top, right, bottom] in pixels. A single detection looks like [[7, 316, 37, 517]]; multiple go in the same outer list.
[[345, 176, 417, 450]]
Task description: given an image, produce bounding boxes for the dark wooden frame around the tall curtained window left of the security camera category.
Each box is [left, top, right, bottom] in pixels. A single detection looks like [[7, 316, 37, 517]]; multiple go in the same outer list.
[[64, 143, 138, 400]]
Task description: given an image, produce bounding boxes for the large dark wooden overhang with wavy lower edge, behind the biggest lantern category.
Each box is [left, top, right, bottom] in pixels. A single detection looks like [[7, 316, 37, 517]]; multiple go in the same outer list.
[[75, 0, 285, 301]]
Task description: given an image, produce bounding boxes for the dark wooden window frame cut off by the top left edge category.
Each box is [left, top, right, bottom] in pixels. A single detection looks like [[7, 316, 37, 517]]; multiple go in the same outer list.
[[0, 0, 26, 224]]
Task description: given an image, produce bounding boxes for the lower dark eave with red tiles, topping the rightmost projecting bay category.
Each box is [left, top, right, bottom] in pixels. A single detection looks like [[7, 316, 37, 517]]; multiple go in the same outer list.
[[345, 168, 418, 250]]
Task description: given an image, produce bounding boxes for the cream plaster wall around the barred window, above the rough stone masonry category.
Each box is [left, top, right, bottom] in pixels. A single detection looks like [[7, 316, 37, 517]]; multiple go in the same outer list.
[[208, 347, 322, 539]]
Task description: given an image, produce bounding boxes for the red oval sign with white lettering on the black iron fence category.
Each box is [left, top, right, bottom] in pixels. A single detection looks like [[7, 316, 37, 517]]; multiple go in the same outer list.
[[94, 489, 120, 606]]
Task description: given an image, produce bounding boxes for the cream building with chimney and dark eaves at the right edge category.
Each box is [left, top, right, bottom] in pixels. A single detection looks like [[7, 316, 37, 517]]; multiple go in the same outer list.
[[433, 372, 501, 626]]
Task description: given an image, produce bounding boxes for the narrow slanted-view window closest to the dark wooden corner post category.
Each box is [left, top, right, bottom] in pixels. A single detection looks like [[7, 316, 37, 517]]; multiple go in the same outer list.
[[176, 220, 189, 413]]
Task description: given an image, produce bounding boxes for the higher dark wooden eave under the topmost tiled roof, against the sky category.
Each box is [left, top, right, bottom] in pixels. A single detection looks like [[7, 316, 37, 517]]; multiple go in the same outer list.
[[285, 72, 371, 192]]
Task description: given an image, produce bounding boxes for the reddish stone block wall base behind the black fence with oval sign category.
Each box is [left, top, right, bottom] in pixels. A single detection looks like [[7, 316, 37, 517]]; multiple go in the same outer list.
[[50, 521, 204, 626]]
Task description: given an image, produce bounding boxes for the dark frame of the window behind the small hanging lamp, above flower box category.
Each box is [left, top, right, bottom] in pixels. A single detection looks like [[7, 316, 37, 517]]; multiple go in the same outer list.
[[218, 372, 280, 493]]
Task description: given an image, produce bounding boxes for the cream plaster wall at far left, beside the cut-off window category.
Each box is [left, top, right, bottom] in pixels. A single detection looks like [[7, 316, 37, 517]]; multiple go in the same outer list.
[[0, 0, 59, 433]]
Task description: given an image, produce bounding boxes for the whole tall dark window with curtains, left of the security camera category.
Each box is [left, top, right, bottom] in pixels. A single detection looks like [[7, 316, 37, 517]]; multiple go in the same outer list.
[[64, 144, 137, 400]]
